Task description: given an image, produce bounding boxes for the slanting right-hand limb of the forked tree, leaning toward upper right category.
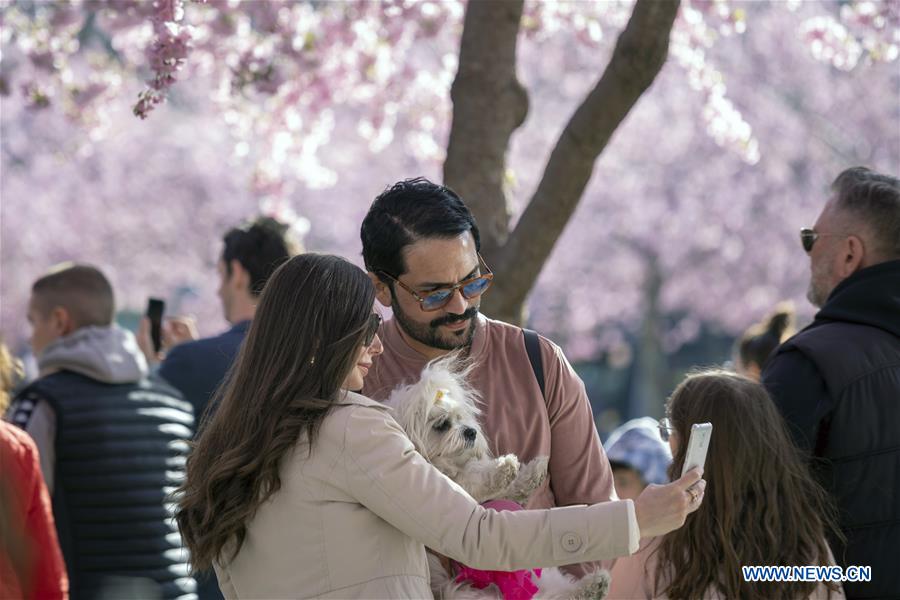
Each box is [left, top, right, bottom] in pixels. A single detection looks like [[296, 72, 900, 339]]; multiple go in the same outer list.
[[485, 0, 679, 322]]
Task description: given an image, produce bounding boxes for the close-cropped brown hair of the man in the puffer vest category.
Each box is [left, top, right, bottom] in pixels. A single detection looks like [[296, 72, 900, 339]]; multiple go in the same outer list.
[[31, 263, 116, 329]]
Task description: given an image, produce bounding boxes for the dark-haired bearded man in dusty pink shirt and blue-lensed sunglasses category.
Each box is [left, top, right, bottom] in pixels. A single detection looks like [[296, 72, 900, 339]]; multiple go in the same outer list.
[[361, 178, 629, 573]]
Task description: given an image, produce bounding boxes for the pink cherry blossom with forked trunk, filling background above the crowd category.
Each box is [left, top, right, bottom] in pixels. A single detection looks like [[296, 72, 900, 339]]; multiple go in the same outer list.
[[0, 0, 900, 394]]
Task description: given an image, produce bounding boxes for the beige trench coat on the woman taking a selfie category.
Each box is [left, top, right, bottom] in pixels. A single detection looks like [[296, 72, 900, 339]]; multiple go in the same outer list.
[[216, 393, 640, 599]]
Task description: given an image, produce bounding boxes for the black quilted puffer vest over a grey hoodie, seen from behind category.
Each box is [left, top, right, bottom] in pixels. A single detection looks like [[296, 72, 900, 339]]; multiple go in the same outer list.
[[18, 371, 196, 600]]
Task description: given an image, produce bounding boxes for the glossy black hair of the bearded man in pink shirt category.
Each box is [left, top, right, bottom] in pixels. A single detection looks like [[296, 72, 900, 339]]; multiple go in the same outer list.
[[360, 177, 481, 283]]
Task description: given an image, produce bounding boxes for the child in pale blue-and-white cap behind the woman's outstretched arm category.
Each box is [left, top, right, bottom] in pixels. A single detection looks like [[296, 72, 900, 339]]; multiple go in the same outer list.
[[605, 417, 672, 500]]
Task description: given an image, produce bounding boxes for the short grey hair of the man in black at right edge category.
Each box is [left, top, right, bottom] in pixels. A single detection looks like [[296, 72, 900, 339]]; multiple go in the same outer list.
[[831, 167, 900, 260]]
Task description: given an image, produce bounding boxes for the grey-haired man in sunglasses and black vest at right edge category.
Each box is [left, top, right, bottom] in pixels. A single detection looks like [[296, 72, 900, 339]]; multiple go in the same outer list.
[[760, 167, 900, 598]]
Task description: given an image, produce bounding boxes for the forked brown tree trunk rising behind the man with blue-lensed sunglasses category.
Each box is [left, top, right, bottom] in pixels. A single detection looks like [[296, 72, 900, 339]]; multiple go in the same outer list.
[[444, 0, 679, 323]]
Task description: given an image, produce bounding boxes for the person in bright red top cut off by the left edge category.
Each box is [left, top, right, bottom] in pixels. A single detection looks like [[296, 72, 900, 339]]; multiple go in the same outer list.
[[0, 341, 69, 600]]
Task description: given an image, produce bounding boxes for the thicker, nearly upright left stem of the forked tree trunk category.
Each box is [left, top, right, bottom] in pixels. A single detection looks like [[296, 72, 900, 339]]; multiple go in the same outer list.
[[444, 0, 528, 262]]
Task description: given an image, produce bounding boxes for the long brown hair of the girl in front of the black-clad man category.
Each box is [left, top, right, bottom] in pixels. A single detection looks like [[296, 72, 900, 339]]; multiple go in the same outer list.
[[655, 370, 838, 600]]
